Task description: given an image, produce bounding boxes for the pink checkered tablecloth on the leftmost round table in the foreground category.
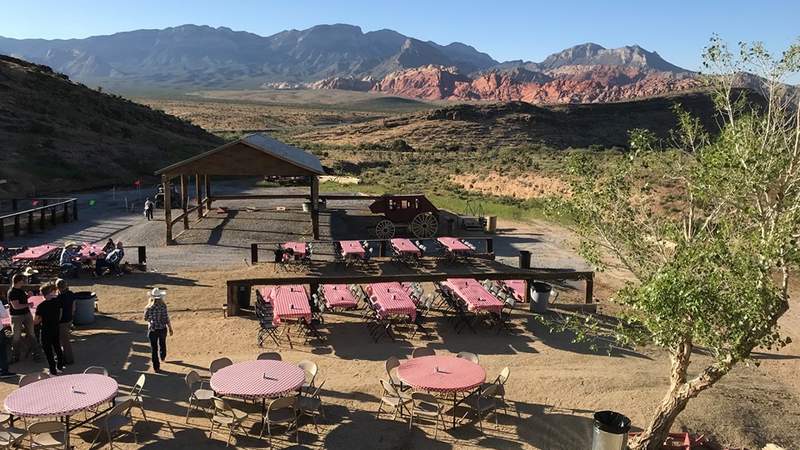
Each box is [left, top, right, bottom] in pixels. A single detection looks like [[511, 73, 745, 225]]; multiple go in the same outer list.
[[5, 374, 118, 417]]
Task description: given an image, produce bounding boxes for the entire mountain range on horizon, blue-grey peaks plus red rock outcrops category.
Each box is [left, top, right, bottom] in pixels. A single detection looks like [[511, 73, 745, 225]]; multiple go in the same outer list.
[[0, 24, 697, 103]]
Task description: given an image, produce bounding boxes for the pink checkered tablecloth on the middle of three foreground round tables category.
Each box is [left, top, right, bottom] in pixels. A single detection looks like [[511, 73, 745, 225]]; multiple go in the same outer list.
[[211, 360, 306, 399]]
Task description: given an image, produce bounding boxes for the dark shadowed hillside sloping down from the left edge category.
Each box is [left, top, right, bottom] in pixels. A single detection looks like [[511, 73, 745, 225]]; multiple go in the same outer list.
[[0, 55, 220, 195]]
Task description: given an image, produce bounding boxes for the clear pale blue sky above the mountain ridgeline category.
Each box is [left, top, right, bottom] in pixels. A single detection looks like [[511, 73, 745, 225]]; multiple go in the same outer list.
[[6, 0, 800, 70]]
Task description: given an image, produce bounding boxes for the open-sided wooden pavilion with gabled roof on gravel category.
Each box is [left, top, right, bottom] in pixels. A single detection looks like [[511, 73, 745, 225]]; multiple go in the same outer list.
[[156, 134, 324, 245]]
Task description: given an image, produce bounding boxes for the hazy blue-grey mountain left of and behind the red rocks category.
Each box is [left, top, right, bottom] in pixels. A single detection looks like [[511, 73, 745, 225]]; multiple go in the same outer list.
[[0, 24, 497, 89]]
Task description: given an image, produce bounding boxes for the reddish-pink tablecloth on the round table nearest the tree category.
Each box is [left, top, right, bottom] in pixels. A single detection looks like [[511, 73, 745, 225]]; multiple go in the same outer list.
[[397, 355, 486, 392]]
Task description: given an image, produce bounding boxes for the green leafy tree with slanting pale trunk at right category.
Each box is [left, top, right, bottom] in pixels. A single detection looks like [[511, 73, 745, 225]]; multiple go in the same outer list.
[[558, 37, 800, 450]]
